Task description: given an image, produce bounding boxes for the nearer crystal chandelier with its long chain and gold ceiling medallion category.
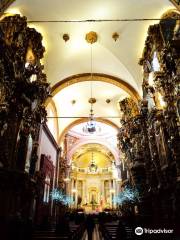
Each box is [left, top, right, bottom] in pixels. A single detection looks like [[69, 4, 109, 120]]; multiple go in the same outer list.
[[83, 32, 101, 134]]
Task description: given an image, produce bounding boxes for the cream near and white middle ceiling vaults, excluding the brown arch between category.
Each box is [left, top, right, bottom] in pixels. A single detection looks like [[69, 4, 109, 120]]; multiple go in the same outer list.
[[7, 0, 174, 141]]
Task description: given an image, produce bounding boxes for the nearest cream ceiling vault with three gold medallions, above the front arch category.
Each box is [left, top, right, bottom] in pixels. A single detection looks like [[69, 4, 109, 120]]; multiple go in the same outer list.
[[7, 0, 173, 93]]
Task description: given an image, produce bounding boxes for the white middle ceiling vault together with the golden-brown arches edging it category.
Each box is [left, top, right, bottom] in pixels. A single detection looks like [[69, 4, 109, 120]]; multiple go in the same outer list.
[[46, 74, 136, 144]]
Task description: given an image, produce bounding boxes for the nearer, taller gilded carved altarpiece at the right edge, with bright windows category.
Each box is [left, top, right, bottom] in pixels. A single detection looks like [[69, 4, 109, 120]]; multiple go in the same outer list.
[[139, 10, 180, 225]]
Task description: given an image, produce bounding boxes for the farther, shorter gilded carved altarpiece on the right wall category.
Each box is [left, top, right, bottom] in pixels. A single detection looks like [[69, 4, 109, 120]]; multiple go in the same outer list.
[[118, 99, 155, 221]]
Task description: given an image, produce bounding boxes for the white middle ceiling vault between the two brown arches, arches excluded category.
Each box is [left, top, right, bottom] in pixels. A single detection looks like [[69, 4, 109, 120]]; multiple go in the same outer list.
[[52, 81, 129, 134]]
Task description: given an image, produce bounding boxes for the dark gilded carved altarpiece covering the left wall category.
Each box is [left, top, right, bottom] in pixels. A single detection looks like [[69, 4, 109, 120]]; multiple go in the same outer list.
[[0, 15, 50, 172]]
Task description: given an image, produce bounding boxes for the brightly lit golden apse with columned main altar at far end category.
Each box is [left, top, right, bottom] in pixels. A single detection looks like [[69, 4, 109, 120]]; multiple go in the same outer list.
[[69, 142, 120, 212]]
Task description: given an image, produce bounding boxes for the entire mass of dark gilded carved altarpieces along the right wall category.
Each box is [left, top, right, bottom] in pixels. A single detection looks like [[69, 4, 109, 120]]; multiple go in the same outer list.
[[118, 11, 180, 223]]
